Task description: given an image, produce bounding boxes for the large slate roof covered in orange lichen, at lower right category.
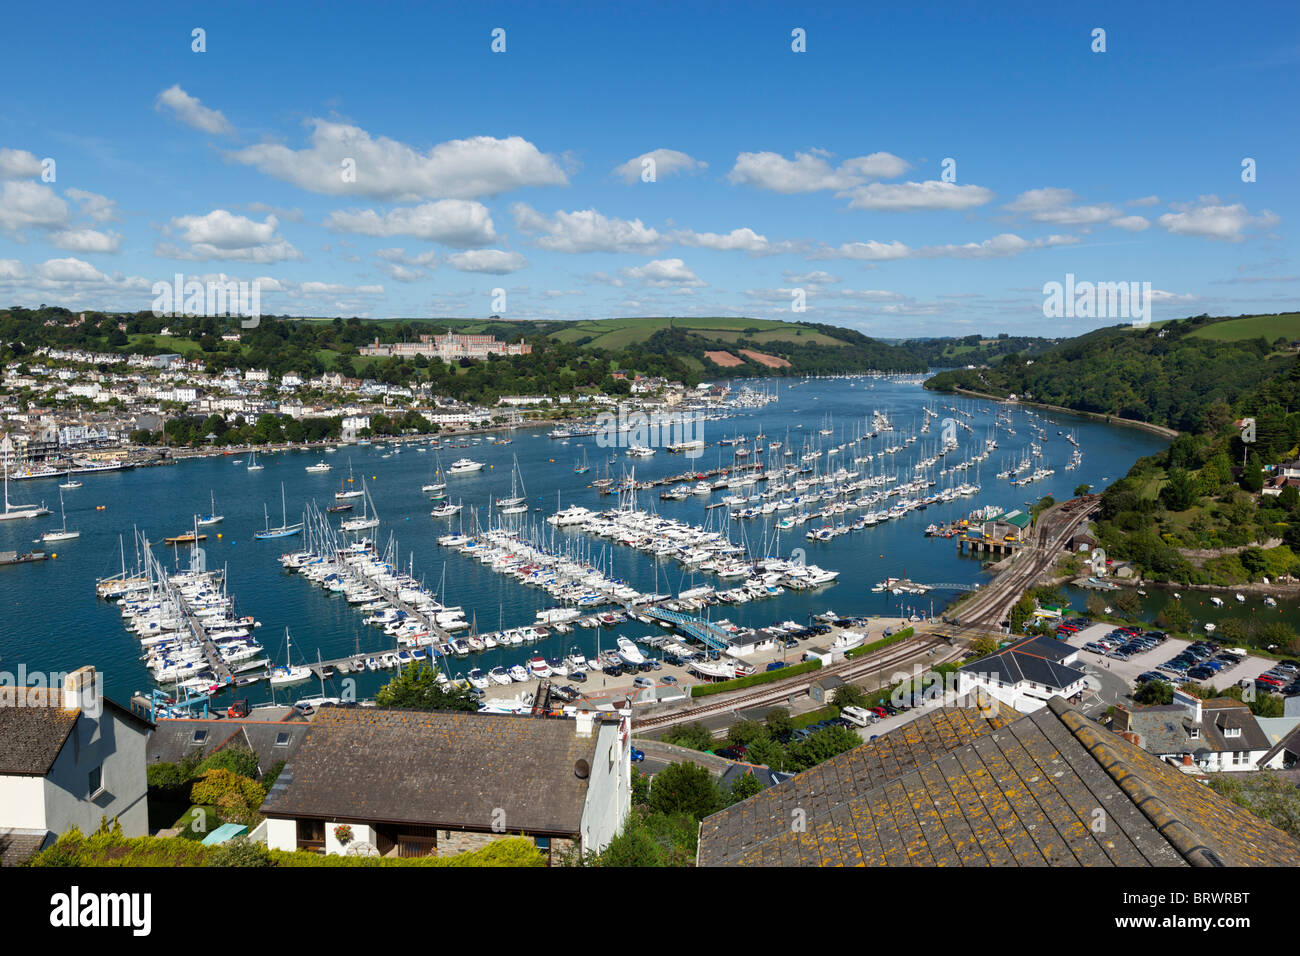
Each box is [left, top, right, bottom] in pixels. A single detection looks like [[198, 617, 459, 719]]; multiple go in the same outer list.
[[699, 697, 1300, 866]]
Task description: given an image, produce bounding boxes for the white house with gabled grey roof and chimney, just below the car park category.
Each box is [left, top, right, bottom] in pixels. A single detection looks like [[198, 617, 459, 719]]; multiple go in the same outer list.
[[1110, 691, 1273, 773]]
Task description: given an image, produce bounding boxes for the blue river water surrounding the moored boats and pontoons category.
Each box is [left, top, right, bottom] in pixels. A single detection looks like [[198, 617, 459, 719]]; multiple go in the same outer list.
[[0, 380, 1165, 701]]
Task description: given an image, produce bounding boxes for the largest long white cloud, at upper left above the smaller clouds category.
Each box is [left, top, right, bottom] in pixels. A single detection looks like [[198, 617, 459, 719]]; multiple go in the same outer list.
[[230, 120, 568, 202]]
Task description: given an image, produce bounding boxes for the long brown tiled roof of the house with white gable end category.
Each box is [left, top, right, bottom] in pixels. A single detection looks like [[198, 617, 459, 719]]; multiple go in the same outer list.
[[261, 708, 608, 835]]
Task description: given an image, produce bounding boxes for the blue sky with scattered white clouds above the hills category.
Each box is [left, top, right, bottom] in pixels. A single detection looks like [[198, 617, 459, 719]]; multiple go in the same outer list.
[[0, 3, 1300, 337]]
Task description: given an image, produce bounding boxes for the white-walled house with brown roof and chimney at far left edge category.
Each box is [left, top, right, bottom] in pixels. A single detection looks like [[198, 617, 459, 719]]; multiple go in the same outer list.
[[0, 667, 152, 865]]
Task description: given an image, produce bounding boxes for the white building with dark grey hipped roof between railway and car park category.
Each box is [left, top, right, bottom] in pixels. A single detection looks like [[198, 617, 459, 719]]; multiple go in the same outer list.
[[957, 637, 1088, 714]]
